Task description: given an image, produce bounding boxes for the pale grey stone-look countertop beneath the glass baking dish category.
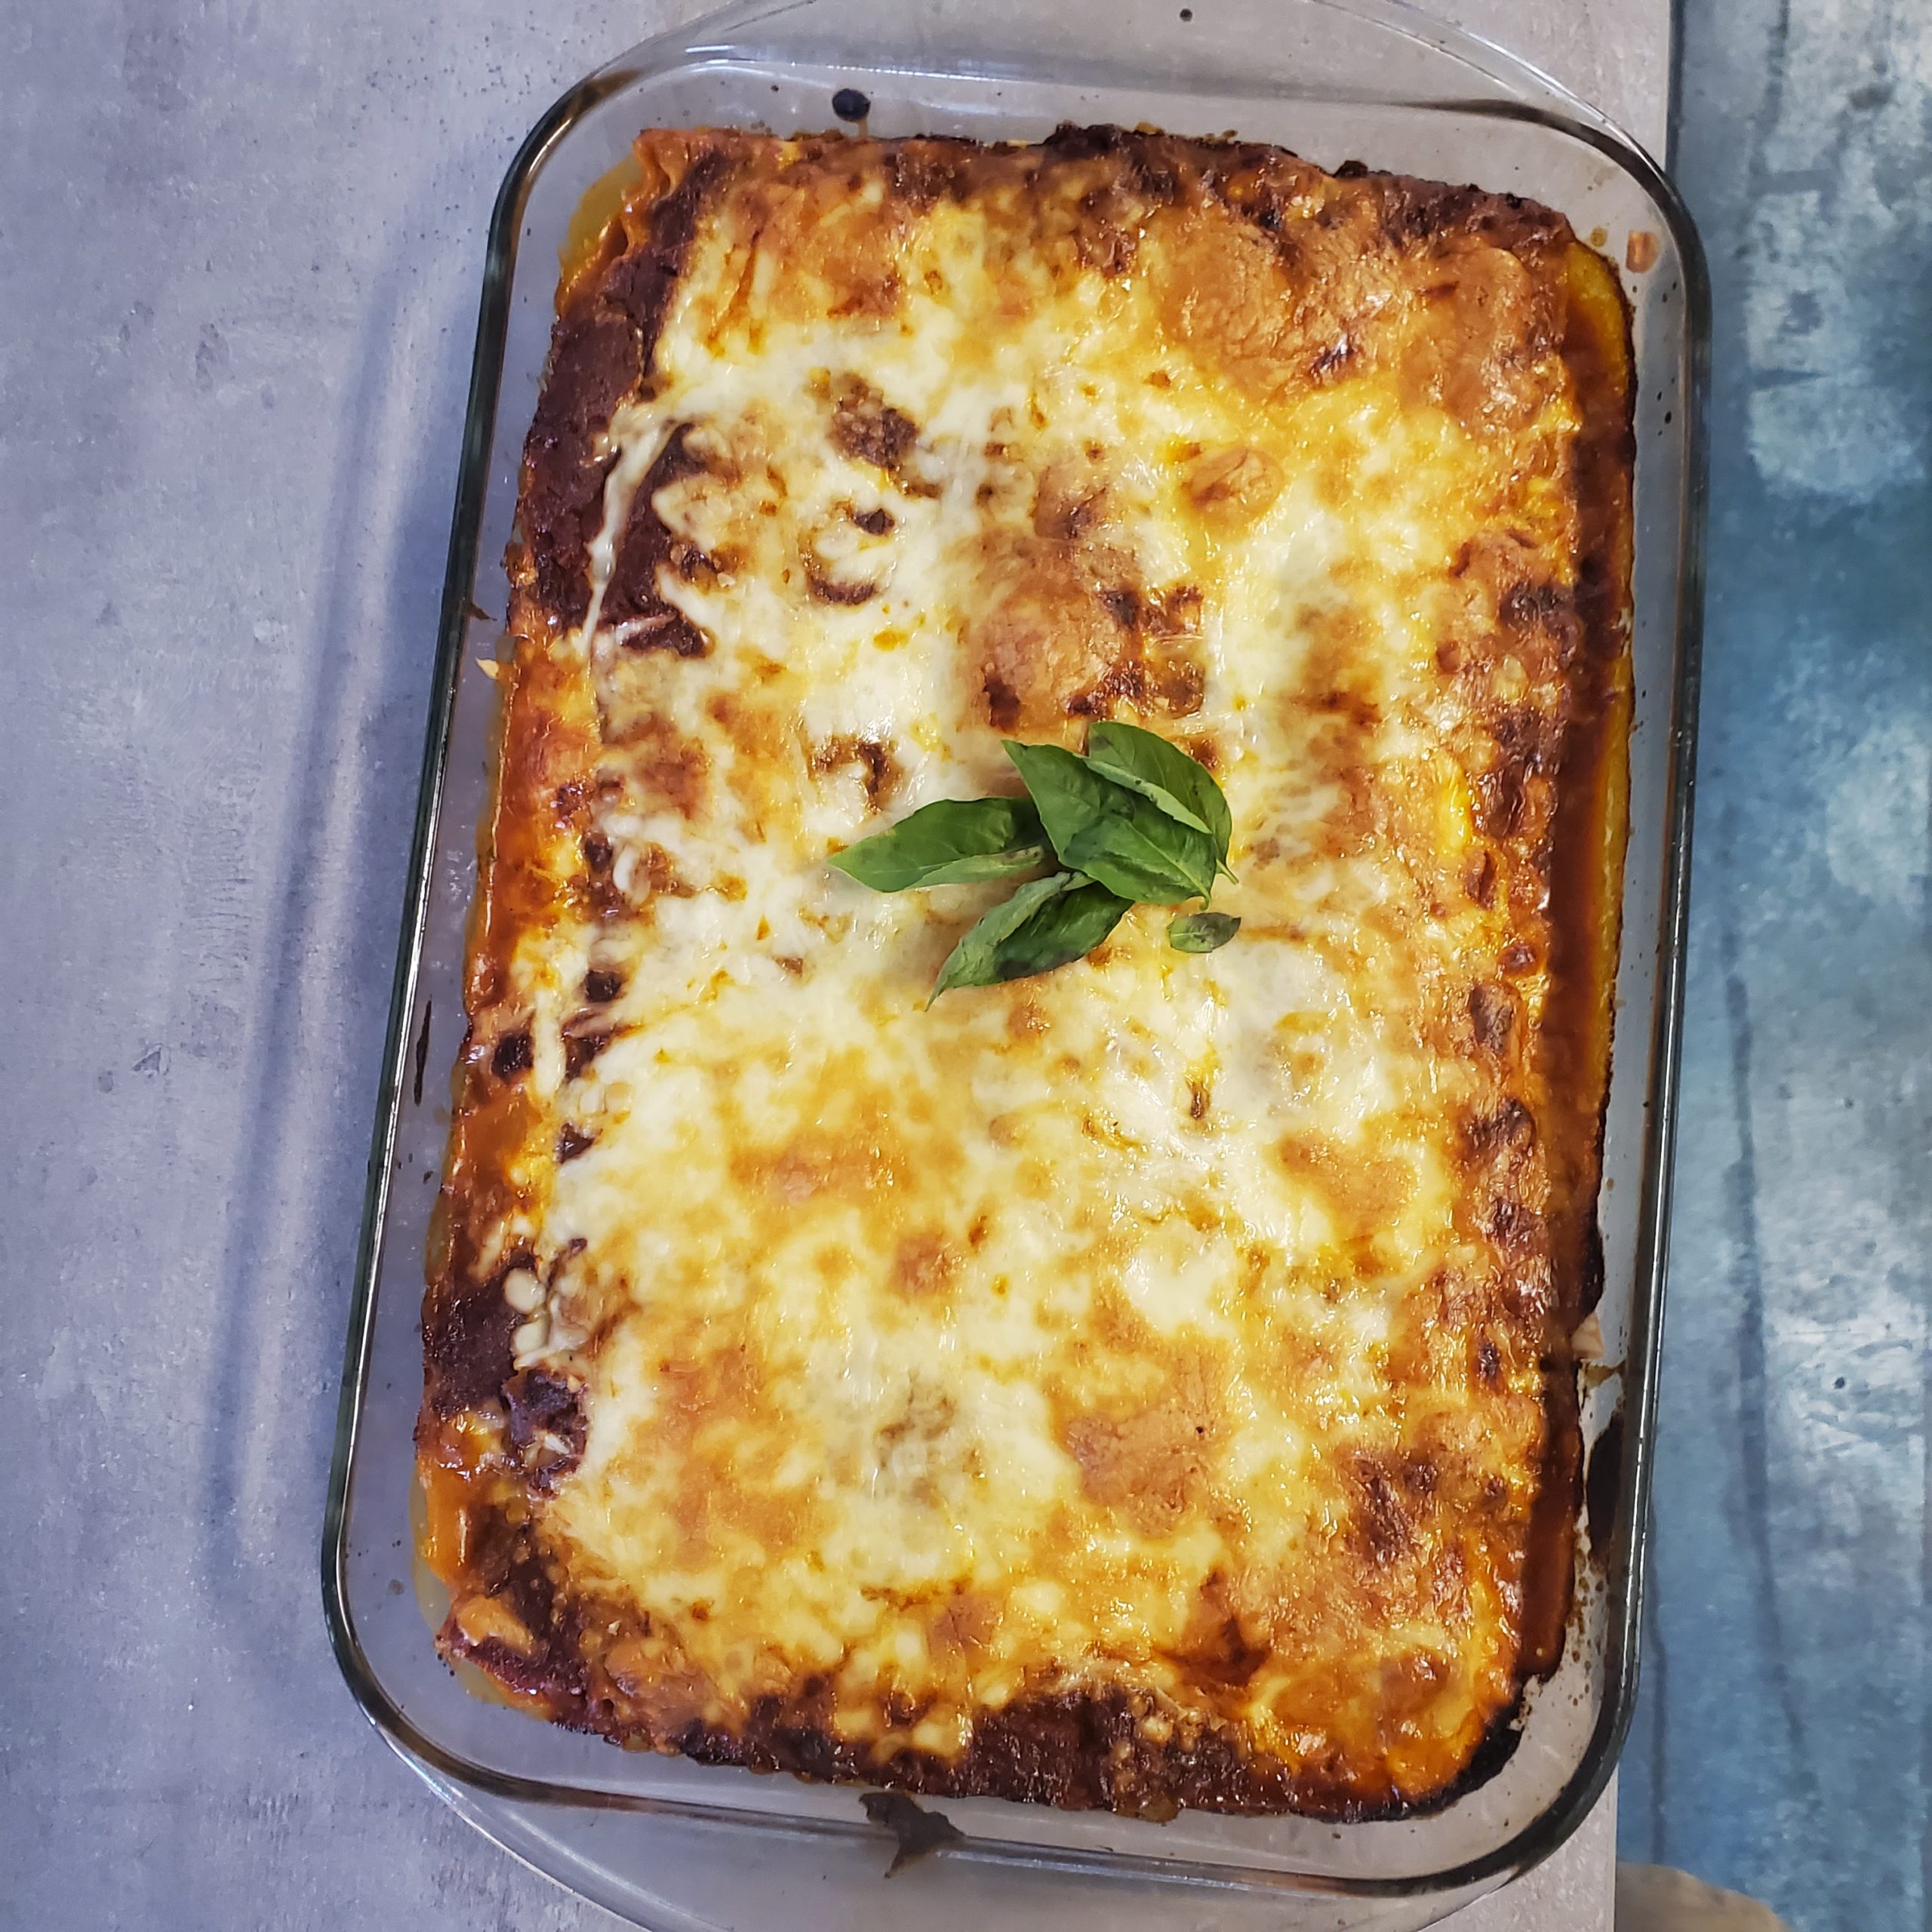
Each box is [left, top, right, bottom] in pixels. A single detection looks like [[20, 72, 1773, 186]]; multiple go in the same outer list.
[[0, 0, 1667, 1932]]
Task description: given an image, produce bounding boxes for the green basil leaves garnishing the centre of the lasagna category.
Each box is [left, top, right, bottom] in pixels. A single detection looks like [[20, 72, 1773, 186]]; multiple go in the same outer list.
[[832, 722, 1241, 999]]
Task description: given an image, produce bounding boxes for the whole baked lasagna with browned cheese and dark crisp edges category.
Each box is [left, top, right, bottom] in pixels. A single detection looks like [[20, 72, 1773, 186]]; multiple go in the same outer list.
[[420, 116, 1632, 1818]]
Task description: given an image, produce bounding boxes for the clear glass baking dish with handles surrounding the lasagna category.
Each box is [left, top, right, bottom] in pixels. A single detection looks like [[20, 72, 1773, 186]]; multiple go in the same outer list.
[[323, 0, 1708, 1926]]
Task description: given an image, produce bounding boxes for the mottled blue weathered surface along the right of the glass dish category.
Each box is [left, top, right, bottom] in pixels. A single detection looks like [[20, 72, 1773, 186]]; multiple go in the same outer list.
[[1619, 0, 1932, 1932]]
